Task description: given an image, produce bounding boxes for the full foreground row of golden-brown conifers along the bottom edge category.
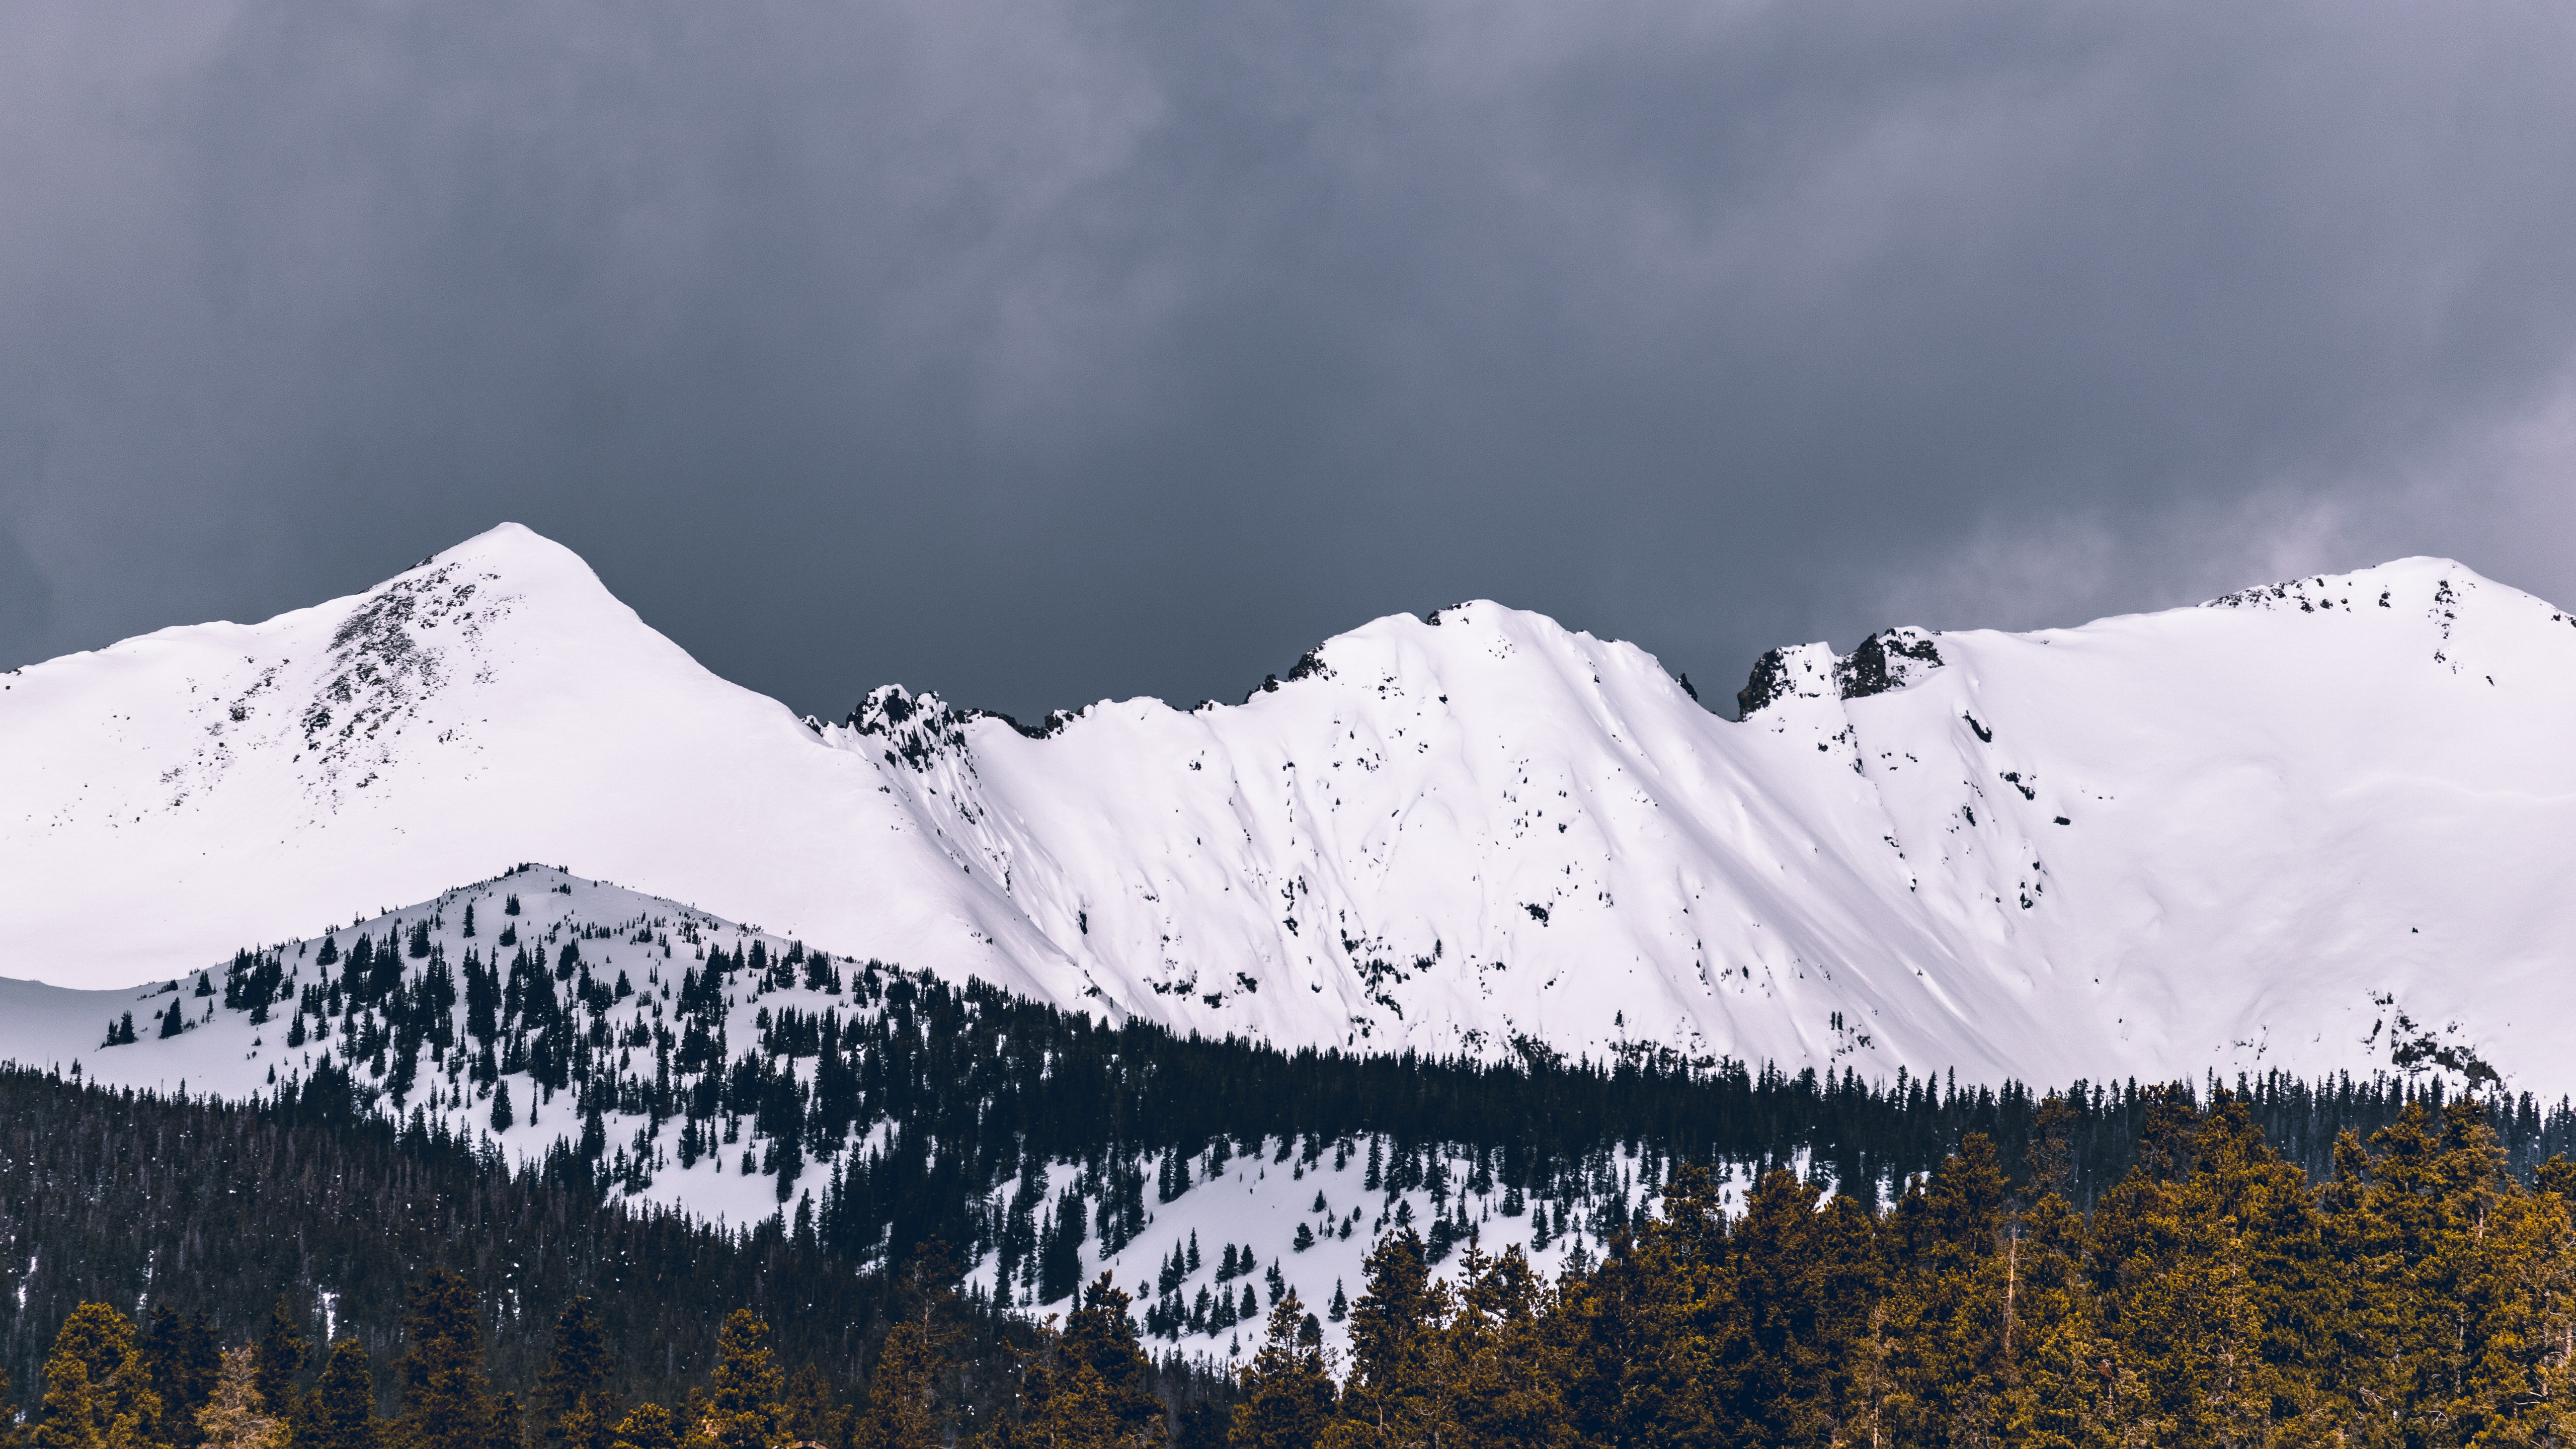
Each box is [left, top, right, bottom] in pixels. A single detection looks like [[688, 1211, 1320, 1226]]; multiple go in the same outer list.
[[10, 1088, 2576, 1449]]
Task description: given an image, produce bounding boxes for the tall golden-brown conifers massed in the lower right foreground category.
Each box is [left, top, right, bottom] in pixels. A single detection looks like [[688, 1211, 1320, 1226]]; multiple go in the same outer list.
[[1211, 1093, 2576, 1449]]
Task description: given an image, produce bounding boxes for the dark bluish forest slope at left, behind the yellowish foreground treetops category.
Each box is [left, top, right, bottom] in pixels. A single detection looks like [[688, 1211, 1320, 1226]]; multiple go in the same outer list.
[[0, 1070, 1051, 1398]]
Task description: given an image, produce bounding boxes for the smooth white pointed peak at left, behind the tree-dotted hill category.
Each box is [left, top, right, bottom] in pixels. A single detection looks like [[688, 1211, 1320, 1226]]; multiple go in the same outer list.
[[0, 523, 1085, 995]]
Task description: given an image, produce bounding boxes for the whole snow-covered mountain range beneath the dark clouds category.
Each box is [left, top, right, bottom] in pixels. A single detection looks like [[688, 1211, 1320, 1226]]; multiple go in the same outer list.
[[0, 526, 2576, 1093]]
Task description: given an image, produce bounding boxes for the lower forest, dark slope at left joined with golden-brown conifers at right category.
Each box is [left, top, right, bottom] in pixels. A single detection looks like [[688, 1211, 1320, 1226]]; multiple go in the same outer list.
[[8, 1078, 2576, 1449]]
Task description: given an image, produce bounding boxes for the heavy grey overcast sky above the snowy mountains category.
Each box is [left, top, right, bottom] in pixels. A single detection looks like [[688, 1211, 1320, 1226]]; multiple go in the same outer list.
[[0, 0, 2576, 717]]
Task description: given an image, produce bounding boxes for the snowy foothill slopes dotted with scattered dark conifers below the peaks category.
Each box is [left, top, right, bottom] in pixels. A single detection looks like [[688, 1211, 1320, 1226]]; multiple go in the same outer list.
[[0, 866, 1710, 1359]]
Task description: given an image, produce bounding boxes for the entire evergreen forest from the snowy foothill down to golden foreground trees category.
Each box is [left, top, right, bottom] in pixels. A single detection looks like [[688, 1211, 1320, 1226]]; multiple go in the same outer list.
[[25, 923, 2576, 1449]]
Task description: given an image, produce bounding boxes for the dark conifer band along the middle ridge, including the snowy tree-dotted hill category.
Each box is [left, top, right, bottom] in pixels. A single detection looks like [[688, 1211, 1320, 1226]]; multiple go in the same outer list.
[[161, 892, 2576, 1284]]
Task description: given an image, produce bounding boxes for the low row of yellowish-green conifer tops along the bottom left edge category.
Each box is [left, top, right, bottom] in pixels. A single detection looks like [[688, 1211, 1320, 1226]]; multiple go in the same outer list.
[[0, 1245, 1195, 1449]]
